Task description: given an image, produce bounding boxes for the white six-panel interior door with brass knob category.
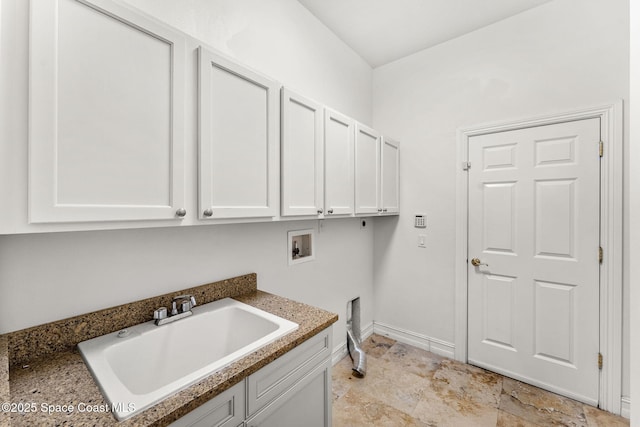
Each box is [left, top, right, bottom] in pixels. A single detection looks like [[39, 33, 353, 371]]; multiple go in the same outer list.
[[468, 118, 600, 405]]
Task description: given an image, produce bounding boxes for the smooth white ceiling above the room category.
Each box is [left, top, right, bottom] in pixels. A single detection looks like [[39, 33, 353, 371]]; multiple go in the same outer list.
[[298, 0, 551, 68]]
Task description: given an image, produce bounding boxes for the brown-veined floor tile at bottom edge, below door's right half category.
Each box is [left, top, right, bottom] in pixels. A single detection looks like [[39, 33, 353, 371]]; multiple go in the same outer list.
[[499, 378, 588, 427]]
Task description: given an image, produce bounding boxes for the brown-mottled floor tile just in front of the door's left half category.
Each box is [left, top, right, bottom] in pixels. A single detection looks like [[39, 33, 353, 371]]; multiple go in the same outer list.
[[432, 359, 502, 408]]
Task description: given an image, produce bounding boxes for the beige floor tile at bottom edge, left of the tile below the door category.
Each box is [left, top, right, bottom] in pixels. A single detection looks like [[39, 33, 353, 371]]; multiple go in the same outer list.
[[411, 390, 498, 427]]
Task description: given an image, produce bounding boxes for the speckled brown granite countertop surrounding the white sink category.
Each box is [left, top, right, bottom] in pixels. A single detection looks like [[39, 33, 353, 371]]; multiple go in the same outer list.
[[0, 276, 338, 427]]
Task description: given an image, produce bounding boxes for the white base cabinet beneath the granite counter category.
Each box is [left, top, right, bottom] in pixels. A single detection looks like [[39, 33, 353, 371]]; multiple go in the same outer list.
[[171, 327, 332, 427]]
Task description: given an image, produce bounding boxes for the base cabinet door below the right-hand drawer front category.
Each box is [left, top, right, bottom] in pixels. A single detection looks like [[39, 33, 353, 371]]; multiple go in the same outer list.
[[247, 359, 332, 427]]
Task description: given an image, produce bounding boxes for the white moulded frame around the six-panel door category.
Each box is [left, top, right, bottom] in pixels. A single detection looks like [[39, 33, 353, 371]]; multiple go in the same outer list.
[[454, 100, 624, 414]]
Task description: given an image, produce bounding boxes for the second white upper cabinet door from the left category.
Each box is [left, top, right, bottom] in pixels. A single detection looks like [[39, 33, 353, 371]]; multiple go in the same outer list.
[[198, 46, 279, 219]]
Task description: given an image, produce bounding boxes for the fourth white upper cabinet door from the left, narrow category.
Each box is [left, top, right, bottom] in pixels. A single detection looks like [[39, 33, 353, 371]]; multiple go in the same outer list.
[[324, 108, 355, 215]]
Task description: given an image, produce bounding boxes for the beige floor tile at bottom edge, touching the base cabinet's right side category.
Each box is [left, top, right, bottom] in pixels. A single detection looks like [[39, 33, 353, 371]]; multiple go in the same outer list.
[[332, 389, 429, 427]]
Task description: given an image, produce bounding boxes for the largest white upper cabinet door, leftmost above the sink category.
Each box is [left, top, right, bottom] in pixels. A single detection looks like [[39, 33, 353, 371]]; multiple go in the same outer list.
[[29, 0, 185, 223]]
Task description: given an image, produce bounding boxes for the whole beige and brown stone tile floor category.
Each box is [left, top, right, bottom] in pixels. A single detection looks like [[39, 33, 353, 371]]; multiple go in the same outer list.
[[333, 335, 629, 427]]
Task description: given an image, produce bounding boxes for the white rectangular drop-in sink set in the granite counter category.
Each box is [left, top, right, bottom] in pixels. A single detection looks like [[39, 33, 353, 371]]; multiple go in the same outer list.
[[78, 298, 298, 421]]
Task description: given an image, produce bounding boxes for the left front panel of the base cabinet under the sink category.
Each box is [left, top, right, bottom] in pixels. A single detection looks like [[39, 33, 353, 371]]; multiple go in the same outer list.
[[170, 381, 245, 427]]
